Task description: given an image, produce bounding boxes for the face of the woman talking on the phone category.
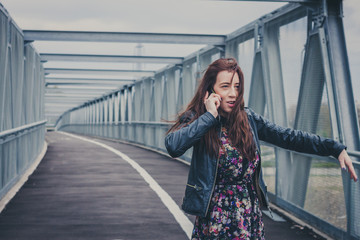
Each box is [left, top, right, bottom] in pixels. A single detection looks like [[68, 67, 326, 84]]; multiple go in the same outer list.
[[214, 70, 240, 115]]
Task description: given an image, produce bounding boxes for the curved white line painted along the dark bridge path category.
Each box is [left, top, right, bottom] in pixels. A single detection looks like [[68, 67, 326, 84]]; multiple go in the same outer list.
[[59, 132, 194, 239]]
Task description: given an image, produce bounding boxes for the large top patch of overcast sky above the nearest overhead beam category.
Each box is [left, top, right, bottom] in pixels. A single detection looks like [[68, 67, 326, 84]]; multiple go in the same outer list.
[[0, 0, 284, 34]]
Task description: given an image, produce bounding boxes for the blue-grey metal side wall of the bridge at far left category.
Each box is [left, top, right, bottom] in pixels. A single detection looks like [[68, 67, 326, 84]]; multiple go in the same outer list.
[[0, 4, 46, 199]]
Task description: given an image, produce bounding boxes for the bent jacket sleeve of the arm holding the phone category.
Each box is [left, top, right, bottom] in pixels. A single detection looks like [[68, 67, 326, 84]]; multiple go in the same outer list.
[[165, 112, 217, 157]]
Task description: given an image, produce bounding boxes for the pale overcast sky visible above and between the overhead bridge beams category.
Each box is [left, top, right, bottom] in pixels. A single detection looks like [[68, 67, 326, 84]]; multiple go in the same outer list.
[[0, 0, 360, 114]]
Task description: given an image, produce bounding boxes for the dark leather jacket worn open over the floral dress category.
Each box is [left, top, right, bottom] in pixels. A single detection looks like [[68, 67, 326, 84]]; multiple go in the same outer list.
[[165, 108, 346, 217]]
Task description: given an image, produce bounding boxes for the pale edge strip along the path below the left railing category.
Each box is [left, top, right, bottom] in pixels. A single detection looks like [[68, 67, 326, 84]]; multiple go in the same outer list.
[[0, 142, 48, 213]]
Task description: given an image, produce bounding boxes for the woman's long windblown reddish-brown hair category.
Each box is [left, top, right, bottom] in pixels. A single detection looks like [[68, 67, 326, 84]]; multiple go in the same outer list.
[[168, 58, 256, 161]]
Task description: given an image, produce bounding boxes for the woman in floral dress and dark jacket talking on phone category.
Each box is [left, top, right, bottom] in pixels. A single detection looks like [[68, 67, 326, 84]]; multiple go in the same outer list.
[[165, 58, 357, 239]]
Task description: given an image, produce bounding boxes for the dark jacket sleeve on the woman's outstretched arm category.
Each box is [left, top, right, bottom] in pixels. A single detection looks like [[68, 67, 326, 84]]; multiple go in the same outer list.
[[250, 110, 346, 158]]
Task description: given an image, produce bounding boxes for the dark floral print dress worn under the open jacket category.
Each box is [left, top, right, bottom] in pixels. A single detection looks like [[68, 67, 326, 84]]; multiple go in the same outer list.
[[192, 127, 265, 240]]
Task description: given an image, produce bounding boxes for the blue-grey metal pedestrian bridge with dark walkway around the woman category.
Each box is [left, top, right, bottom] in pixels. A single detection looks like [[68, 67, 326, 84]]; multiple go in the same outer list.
[[0, 0, 360, 239]]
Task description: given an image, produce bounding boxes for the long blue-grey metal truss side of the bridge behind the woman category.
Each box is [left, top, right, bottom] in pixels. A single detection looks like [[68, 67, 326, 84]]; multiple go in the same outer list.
[[56, 1, 360, 239]]
